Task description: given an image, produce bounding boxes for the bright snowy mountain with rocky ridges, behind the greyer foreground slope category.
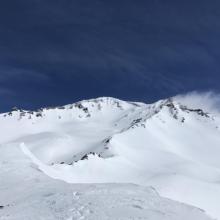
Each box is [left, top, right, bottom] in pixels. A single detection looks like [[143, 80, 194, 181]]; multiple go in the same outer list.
[[0, 97, 220, 219]]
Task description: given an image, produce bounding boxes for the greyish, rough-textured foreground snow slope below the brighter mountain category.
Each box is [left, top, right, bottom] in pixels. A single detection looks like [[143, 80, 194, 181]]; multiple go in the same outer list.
[[0, 142, 211, 220]]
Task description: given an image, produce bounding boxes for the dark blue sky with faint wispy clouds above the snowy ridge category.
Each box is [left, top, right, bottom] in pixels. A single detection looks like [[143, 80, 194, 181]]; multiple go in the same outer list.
[[0, 0, 220, 112]]
